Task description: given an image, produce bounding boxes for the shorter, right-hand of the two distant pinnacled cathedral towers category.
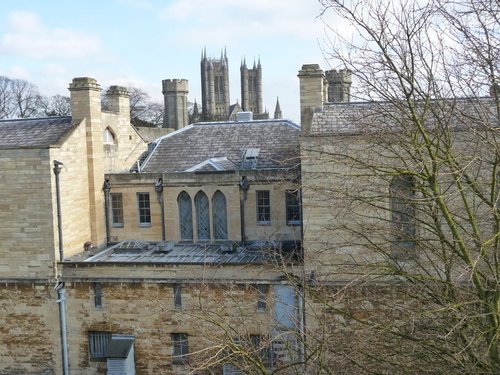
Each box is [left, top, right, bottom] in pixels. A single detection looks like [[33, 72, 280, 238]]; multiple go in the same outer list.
[[240, 59, 263, 114]]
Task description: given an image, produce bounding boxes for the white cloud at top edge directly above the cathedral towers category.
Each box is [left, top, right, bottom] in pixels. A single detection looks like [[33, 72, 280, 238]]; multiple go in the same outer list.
[[162, 0, 323, 44]]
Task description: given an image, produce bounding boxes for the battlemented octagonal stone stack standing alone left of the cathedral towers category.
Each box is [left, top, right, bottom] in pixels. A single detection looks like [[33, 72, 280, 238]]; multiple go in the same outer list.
[[162, 79, 189, 130]]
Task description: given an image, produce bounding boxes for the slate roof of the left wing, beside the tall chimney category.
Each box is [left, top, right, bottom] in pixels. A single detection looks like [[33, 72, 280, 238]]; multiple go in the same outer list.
[[0, 116, 72, 148]]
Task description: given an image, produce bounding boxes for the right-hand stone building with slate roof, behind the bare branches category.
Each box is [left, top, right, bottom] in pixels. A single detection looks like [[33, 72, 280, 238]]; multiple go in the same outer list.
[[299, 64, 498, 373]]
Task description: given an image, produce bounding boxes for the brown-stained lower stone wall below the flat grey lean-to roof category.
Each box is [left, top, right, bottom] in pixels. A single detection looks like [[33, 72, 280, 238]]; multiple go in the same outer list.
[[63, 283, 278, 375]]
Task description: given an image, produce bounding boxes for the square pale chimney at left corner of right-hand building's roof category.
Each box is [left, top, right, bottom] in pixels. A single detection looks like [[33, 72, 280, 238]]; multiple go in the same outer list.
[[298, 64, 328, 133]]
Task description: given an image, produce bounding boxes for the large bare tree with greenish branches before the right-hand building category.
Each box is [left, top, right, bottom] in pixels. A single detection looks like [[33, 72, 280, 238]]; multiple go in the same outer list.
[[294, 0, 500, 373]]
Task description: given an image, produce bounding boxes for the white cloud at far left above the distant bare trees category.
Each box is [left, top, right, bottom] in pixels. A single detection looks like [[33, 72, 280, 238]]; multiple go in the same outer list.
[[0, 12, 101, 59]]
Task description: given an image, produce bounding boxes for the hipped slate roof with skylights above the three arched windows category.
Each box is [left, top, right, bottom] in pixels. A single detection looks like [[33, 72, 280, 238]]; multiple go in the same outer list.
[[141, 120, 300, 173]]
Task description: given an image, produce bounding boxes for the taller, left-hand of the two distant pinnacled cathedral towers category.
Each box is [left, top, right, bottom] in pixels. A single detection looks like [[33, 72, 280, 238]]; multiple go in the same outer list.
[[200, 49, 229, 121]]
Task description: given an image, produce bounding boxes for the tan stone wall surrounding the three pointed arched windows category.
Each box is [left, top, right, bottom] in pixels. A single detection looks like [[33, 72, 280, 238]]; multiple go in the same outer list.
[[108, 173, 301, 242]]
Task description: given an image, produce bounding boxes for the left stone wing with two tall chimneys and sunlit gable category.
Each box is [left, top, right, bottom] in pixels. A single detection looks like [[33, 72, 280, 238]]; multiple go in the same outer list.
[[0, 78, 146, 374]]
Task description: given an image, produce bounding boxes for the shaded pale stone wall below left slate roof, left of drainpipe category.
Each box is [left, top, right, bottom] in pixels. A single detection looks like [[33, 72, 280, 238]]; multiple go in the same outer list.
[[0, 149, 56, 279]]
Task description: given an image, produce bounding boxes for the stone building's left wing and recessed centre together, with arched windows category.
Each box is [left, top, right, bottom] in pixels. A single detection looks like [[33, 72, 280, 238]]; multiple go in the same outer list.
[[0, 74, 302, 374]]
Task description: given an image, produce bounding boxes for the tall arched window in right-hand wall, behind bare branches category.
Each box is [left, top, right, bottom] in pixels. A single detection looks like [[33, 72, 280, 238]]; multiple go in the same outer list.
[[390, 174, 416, 250]]
